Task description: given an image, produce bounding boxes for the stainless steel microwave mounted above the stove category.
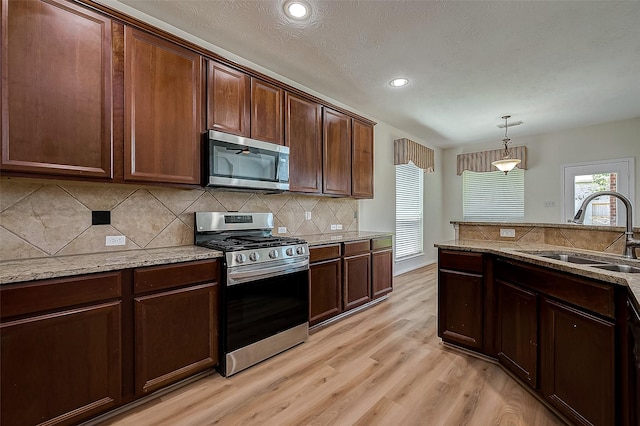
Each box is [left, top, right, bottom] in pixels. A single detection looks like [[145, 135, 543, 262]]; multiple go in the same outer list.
[[205, 130, 289, 192]]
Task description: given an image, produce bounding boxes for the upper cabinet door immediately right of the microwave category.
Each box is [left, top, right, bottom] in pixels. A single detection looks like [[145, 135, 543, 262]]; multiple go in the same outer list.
[[285, 93, 322, 193]]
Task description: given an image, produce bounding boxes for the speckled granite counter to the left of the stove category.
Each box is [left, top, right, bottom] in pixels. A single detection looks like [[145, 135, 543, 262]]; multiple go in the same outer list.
[[0, 246, 222, 284]]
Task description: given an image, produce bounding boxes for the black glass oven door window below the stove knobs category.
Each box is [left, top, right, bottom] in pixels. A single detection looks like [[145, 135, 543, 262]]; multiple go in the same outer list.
[[223, 271, 309, 352]]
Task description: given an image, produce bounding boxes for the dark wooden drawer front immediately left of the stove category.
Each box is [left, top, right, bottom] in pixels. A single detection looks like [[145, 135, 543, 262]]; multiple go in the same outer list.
[[133, 260, 218, 294]]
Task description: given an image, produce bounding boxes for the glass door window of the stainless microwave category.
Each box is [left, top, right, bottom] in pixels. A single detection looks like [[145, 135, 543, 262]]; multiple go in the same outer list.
[[210, 141, 280, 181]]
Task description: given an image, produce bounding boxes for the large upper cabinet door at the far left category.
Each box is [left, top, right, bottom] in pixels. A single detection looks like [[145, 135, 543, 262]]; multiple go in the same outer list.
[[0, 0, 113, 178]]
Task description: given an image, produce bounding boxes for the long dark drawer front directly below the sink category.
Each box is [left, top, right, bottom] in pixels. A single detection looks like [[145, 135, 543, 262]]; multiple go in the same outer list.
[[494, 259, 615, 318]]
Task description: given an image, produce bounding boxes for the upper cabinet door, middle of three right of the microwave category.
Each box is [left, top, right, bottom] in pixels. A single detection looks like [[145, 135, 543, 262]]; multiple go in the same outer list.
[[322, 108, 351, 196]]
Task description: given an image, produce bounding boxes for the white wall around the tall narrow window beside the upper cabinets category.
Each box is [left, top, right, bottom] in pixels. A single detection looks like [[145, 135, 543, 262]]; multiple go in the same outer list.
[[358, 122, 445, 275]]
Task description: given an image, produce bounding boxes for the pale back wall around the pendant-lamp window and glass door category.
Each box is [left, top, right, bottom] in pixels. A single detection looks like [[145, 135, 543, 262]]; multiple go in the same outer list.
[[443, 118, 640, 238]]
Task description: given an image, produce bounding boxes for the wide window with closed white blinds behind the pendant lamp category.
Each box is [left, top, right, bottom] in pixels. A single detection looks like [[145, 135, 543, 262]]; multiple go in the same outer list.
[[462, 168, 524, 222]]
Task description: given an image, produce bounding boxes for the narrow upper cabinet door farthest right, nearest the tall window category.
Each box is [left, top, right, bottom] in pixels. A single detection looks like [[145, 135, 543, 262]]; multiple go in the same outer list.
[[351, 120, 373, 198]]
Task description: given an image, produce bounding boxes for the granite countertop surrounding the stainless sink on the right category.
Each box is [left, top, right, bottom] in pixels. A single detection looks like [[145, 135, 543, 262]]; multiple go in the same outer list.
[[434, 240, 640, 307]]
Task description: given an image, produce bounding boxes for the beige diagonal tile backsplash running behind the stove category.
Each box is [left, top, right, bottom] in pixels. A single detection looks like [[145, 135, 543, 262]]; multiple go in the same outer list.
[[0, 177, 358, 260]]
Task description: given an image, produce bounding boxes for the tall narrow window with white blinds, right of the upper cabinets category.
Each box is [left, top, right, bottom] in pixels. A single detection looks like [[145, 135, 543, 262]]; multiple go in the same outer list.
[[395, 163, 424, 260]]
